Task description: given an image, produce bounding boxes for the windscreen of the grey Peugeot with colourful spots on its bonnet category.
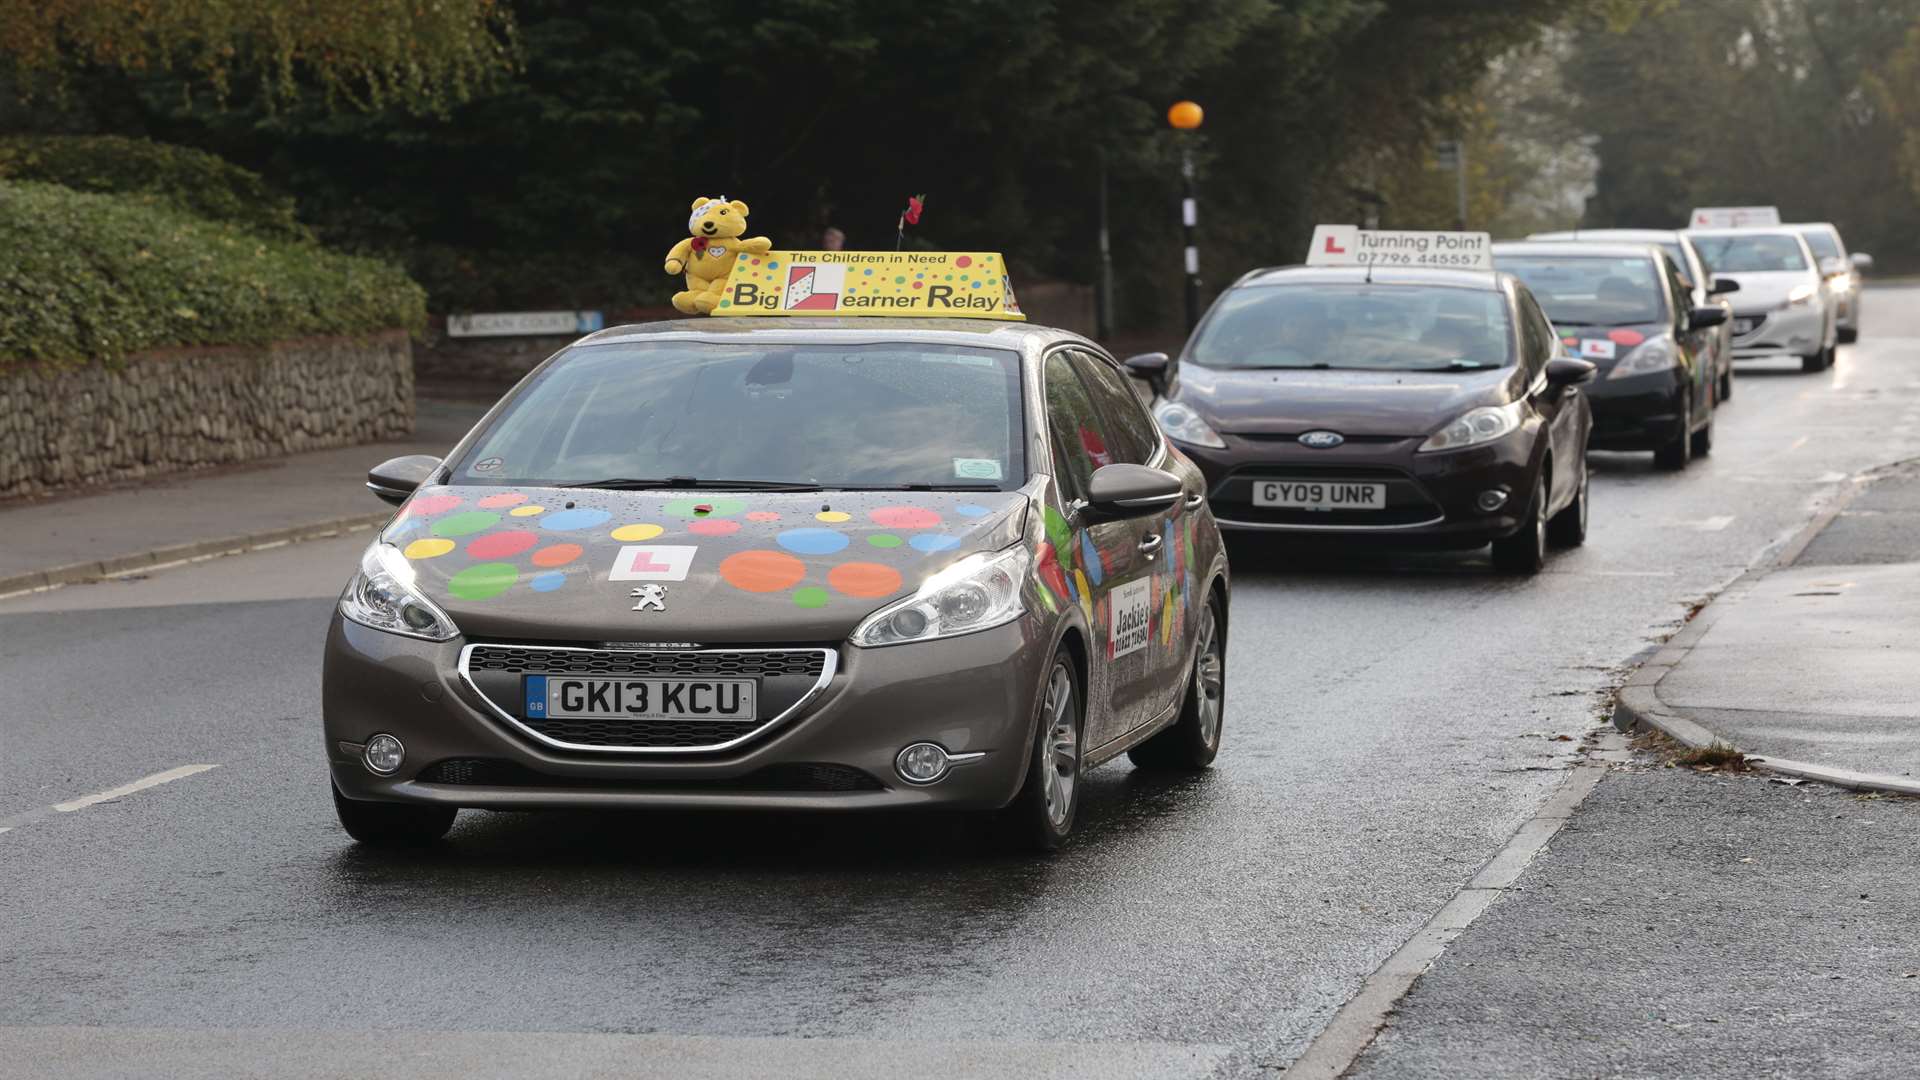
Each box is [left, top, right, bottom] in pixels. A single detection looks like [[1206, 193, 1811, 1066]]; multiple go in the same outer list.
[[453, 342, 1025, 490]]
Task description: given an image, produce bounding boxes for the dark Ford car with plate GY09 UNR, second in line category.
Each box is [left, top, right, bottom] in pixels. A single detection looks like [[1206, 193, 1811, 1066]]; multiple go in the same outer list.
[[1127, 267, 1594, 573]]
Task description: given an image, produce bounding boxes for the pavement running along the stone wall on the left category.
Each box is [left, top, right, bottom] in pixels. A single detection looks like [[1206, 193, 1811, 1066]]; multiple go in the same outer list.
[[0, 400, 486, 596]]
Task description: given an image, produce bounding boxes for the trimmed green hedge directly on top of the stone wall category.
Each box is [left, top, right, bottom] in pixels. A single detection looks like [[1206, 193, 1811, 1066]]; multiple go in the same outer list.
[[0, 181, 426, 363]]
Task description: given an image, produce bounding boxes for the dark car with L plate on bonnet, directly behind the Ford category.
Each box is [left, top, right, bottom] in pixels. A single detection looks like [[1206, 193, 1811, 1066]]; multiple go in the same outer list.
[[1494, 240, 1728, 469]]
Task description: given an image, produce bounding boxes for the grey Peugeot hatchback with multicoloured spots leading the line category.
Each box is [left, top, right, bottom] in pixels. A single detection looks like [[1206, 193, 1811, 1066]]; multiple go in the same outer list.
[[323, 317, 1229, 849]]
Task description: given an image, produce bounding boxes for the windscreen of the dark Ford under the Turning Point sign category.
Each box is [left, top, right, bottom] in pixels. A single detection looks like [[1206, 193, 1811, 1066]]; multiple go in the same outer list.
[[1187, 284, 1513, 371]]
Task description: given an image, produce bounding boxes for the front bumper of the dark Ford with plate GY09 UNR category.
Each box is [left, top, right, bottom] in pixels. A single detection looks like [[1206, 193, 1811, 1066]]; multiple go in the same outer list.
[[1181, 425, 1538, 548]]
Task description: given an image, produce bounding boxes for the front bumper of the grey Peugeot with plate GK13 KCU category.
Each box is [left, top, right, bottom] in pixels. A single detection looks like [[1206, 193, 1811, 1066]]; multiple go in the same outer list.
[[323, 613, 1052, 809]]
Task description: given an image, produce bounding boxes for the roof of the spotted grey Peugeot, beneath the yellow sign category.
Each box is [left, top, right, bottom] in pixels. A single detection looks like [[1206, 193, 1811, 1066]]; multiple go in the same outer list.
[[574, 315, 1092, 352]]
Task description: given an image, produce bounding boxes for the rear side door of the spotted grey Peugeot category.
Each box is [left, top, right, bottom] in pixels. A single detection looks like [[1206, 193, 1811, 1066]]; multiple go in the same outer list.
[[1069, 350, 1200, 736]]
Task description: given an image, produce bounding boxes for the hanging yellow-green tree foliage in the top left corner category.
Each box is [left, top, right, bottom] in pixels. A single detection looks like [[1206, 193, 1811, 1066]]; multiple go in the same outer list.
[[0, 0, 513, 110]]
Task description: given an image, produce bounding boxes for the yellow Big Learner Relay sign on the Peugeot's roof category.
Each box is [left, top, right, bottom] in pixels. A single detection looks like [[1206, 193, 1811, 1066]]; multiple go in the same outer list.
[[712, 252, 1025, 321]]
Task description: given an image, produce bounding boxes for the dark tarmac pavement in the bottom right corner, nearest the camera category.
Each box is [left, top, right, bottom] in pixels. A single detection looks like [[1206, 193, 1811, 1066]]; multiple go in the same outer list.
[[1350, 755, 1920, 1080]]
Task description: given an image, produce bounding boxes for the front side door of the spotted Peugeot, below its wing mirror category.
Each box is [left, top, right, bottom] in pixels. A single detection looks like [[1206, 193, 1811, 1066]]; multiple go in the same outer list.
[[1041, 348, 1146, 748]]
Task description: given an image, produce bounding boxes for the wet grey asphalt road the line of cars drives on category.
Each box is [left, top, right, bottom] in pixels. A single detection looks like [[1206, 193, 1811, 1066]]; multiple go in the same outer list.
[[11, 290, 1920, 1076]]
